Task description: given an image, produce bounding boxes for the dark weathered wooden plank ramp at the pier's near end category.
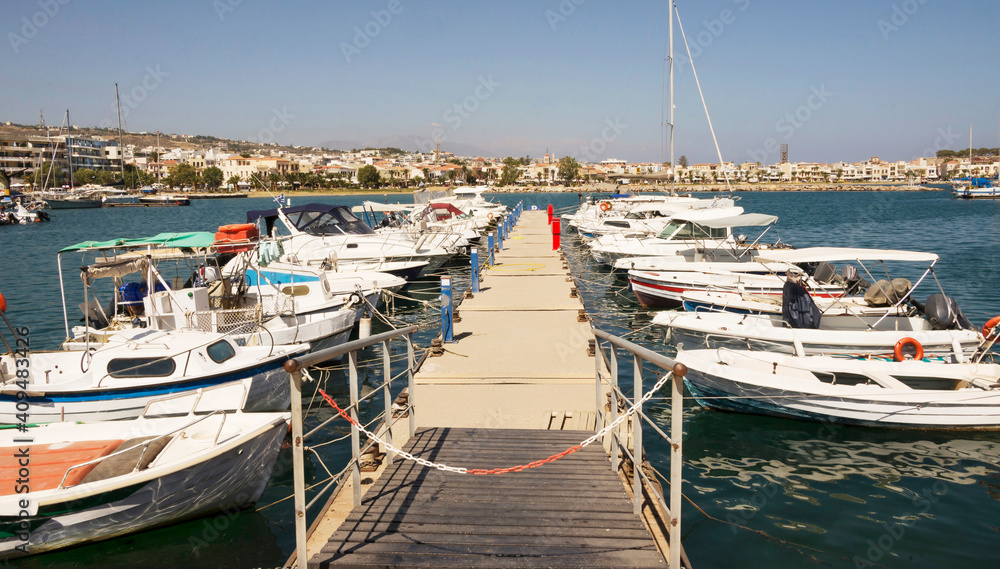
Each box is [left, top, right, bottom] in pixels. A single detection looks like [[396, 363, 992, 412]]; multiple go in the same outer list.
[[309, 427, 666, 568]]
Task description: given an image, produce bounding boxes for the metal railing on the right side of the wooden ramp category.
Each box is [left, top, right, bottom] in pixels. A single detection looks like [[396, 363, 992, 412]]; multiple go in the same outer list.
[[593, 328, 687, 568]]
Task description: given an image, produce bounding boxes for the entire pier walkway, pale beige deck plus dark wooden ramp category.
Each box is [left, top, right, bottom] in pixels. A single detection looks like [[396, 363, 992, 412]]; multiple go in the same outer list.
[[296, 211, 667, 568]]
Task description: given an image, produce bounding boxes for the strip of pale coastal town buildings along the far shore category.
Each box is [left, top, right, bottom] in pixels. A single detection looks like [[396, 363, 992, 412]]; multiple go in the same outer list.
[[0, 126, 1000, 189]]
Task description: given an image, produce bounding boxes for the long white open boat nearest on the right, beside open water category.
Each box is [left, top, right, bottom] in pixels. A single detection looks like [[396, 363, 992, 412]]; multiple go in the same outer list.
[[677, 349, 1000, 430]]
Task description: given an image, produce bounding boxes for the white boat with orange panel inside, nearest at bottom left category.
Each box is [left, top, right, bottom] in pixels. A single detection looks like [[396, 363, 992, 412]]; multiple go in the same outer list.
[[0, 382, 289, 559]]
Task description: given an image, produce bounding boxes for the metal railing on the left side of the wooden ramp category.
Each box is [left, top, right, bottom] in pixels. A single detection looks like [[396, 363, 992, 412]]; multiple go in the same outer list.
[[285, 326, 419, 569]]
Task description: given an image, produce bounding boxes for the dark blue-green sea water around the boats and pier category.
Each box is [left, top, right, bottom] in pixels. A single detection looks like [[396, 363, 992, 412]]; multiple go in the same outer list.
[[0, 191, 1000, 569]]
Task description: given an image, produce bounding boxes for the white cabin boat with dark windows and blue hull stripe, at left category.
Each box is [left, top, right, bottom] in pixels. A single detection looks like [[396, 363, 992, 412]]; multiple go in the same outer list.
[[0, 328, 309, 425]]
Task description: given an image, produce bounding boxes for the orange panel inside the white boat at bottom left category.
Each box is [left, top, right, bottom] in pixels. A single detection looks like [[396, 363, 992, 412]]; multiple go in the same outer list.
[[0, 439, 123, 496]]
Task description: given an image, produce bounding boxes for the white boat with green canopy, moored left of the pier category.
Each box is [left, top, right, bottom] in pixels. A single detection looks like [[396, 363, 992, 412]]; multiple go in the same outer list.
[[60, 232, 358, 351]]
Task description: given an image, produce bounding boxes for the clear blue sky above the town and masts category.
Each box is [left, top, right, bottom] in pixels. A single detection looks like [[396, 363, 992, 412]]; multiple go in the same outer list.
[[0, 0, 1000, 163]]
